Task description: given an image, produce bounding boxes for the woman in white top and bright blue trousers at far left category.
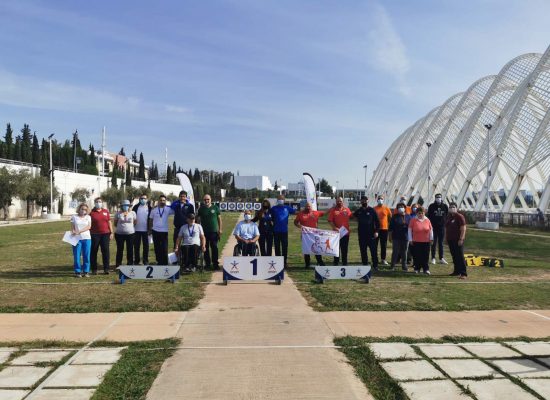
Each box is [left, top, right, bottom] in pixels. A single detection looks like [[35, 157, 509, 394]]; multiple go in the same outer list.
[[71, 203, 92, 278]]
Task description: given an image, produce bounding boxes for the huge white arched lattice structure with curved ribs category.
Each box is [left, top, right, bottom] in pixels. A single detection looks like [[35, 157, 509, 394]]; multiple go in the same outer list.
[[368, 47, 550, 212]]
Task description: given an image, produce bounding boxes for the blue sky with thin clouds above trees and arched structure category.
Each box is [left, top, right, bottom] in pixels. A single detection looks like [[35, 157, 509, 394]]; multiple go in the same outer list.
[[0, 0, 550, 188]]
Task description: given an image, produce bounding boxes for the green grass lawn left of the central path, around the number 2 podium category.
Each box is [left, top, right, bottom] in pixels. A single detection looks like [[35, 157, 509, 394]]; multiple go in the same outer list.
[[0, 213, 242, 312]]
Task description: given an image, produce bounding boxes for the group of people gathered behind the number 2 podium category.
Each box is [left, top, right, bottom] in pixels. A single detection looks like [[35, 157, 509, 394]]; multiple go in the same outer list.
[[71, 190, 222, 277]]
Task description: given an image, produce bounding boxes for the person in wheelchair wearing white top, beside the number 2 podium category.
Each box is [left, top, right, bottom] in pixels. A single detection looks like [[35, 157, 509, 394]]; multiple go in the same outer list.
[[174, 214, 206, 272]]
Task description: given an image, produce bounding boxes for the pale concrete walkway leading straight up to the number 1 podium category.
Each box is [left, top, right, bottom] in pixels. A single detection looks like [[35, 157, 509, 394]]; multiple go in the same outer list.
[[147, 233, 372, 400]]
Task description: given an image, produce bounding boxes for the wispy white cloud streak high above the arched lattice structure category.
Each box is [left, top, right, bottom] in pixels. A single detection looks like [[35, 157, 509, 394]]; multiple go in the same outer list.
[[368, 4, 410, 96]]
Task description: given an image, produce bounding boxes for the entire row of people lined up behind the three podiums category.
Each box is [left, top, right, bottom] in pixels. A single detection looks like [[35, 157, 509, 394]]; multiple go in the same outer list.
[[71, 191, 467, 279]]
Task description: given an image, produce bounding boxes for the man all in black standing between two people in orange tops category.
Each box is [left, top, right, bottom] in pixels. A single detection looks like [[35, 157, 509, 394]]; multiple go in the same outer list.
[[351, 196, 380, 271]]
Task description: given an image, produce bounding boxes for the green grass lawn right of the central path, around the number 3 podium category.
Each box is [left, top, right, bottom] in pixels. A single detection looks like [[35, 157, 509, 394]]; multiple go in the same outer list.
[[289, 219, 550, 311]]
